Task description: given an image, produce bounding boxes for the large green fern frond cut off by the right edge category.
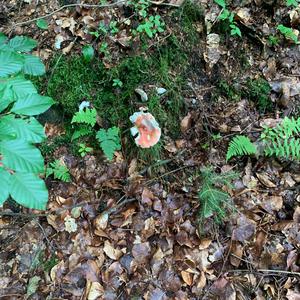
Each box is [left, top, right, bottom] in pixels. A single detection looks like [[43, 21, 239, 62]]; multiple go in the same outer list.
[[261, 117, 300, 160]]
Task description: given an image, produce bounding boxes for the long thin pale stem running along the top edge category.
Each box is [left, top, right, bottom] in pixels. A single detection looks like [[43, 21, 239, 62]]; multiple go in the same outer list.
[[12, 0, 181, 27]]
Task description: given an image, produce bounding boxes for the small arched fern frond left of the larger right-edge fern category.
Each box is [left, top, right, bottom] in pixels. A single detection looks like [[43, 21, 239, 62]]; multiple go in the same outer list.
[[226, 135, 256, 161]]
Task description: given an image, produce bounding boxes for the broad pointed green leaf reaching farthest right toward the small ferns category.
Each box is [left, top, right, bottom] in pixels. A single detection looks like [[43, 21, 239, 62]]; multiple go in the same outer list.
[[11, 94, 54, 116]]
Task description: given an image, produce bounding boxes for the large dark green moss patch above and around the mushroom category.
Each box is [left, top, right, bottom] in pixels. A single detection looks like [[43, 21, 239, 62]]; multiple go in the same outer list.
[[35, 2, 203, 163]]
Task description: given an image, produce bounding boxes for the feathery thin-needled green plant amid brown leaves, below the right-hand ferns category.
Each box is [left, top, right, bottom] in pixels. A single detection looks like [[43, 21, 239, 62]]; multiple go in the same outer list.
[[198, 168, 238, 222]]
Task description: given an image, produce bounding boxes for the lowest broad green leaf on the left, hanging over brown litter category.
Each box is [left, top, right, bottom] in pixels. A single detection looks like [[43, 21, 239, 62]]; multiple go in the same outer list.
[[10, 172, 48, 210]]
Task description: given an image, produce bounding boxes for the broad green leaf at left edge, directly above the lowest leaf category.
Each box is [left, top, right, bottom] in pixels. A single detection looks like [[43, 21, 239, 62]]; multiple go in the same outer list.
[[0, 139, 44, 173]]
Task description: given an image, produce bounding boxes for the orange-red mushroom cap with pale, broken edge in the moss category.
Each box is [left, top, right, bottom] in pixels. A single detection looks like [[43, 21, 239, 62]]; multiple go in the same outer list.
[[129, 112, 161, 148]]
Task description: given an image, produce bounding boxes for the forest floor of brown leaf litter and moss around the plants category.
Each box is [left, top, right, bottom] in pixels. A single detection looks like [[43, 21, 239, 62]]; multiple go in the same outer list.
[[0, 0, 300, 300]]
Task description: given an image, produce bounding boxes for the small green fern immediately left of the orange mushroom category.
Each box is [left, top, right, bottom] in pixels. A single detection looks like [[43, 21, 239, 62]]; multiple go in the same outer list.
[[96, 126, 121, 160]]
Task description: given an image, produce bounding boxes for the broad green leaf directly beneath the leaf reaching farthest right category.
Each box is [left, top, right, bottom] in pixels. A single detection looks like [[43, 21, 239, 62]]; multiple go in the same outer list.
[[0, 115, 46, 143]]
